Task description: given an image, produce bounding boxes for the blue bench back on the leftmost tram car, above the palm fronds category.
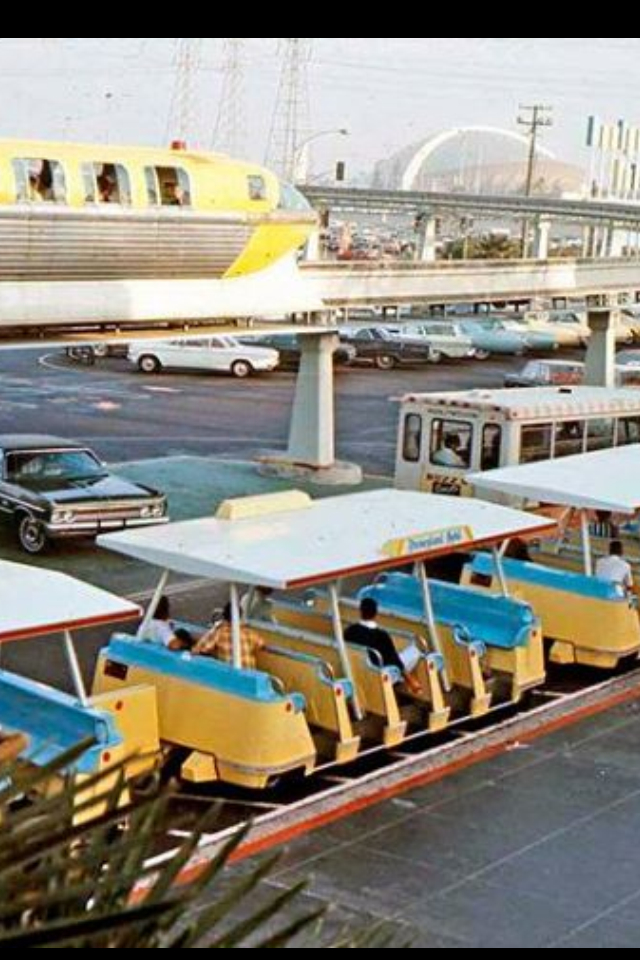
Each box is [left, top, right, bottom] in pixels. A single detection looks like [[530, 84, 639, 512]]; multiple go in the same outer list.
[[0, 671, 122, 775]]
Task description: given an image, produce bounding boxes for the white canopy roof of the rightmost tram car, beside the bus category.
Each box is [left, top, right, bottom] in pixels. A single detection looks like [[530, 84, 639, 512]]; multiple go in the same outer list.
[[469, 445, 640, 514]]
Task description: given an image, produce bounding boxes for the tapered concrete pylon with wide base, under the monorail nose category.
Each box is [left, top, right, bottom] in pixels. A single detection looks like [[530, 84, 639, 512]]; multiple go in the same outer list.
[[260, 331, 363, 486]]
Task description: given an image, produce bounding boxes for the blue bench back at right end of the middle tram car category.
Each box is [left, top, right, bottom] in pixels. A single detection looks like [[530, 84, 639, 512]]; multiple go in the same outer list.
[[359, 572, 538, 650]]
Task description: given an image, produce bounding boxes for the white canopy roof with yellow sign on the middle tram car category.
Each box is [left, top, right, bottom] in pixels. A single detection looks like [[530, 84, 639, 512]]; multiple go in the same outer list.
[[99, 490, 555, 590]]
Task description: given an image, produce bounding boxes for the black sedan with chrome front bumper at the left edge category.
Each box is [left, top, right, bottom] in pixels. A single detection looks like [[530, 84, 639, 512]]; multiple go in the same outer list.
[[0, 436, 168, 554]]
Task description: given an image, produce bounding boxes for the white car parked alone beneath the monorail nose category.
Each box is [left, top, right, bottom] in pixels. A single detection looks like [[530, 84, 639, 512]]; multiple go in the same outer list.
[[129, 337, 280, 380]]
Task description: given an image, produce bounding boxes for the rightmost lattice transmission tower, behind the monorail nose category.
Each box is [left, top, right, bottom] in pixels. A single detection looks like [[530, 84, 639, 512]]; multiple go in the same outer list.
[[267, 37, 312, 181]]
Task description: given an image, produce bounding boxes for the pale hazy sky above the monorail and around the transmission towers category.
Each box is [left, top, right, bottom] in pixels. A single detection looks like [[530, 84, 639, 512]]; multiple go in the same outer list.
[[0, 37, 640, 168]]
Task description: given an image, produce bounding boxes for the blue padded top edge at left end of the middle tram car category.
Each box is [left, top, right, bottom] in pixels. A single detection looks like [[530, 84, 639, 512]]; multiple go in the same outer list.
[[103, 636, 305, 713]]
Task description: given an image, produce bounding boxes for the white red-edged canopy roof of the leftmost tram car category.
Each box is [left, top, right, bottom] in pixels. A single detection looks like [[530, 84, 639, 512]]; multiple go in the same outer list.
[[0, 561, 141, 643]]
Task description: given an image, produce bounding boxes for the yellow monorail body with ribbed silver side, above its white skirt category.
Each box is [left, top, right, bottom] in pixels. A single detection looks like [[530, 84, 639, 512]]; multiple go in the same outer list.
[[0, 140, 316, 285]]
